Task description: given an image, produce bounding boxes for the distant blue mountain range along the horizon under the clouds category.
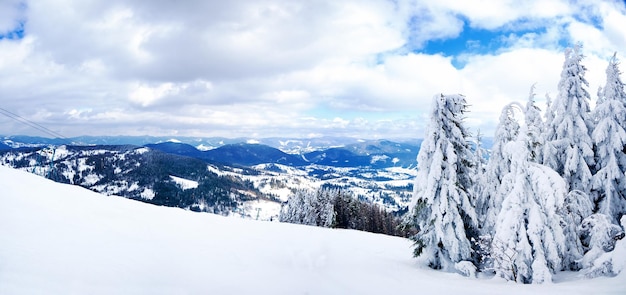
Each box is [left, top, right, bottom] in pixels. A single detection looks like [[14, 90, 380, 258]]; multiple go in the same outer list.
[[0, 136, 421, 168]]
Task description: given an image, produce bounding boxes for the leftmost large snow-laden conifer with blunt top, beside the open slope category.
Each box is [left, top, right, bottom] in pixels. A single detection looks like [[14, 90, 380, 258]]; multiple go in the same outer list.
[[410, 94, 476, 270]]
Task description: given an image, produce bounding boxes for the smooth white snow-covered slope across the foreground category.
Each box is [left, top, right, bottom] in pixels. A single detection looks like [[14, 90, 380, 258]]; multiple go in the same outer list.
[[0, 166, 626, 295]]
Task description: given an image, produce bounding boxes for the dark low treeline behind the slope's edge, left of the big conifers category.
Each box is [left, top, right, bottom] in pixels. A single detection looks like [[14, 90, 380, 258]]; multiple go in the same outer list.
[[279, 188, 409, 237]]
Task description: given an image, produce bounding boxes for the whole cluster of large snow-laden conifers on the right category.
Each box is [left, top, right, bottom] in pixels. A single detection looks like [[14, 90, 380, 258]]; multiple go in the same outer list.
[[409, 46, 626, 283]]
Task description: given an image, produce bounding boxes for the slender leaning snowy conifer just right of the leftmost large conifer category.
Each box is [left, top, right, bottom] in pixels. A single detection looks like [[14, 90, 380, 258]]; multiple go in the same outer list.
[[476, 103, 521, 235]]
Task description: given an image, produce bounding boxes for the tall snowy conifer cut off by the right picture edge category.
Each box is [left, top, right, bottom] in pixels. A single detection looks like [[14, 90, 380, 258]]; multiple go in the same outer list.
[[592, 55, 626, 224]]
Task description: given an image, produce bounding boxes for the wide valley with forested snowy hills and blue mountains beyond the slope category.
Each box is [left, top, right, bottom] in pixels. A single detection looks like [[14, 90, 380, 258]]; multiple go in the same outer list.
[[0, 137, 419, 220]]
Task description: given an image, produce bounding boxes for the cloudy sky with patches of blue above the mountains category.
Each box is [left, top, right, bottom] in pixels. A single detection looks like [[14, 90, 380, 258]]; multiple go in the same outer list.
[[0, 0, 626, 139]]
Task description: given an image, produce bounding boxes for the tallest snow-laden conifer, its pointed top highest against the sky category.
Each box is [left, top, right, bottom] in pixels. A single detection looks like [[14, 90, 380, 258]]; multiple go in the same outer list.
[[544, 45, 594, 194]]
